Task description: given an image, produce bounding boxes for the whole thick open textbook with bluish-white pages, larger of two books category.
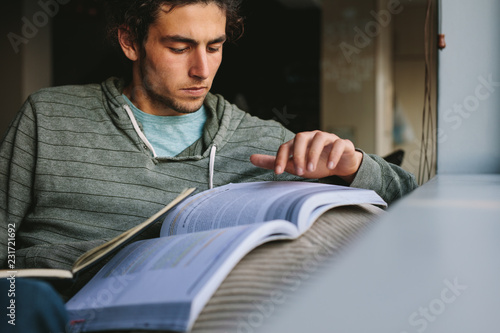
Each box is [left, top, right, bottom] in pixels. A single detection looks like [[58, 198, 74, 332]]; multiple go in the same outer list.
[[66, 182, 386, 332]]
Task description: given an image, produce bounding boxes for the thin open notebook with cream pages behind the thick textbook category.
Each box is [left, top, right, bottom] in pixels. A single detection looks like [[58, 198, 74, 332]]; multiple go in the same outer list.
[[0, 188, 195, 279]]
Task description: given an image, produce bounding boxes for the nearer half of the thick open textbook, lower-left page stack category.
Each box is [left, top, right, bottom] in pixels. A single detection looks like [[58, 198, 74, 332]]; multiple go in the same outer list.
[[66, 221, 294, 331]]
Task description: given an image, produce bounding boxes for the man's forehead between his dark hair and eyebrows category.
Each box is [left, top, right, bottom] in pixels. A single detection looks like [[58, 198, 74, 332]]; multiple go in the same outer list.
[[150, 3, 226, 40]]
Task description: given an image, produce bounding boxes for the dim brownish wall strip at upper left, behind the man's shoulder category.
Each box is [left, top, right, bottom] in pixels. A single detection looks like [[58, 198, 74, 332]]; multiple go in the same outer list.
[[0, 0, 52, 135]]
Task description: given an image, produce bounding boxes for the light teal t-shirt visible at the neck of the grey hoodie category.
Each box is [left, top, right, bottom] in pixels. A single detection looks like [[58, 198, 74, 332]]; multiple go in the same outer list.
[[123, 95, 207, 157]]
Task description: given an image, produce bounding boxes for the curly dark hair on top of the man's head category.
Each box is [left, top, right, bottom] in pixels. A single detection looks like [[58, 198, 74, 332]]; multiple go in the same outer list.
[[102, 0, 243, 46]]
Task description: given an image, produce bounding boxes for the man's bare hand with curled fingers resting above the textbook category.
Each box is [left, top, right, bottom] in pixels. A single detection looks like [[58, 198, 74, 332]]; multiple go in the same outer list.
[[250, 131, 363, 184]]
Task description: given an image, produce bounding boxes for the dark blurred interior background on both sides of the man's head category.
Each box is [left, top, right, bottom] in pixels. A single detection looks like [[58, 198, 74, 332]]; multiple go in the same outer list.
[[0, 0, 438, 178]]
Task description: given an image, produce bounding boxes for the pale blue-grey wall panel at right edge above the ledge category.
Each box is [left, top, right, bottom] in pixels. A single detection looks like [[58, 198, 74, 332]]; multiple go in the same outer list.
[[438, 0, 500, 174]]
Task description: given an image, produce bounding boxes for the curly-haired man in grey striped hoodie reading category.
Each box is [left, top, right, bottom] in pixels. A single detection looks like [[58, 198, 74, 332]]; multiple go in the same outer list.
[[0, 0, 416, 296]]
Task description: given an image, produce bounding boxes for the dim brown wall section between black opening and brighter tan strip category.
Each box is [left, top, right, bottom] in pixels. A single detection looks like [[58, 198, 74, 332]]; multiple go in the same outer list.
[[321, 0, 376, 153]]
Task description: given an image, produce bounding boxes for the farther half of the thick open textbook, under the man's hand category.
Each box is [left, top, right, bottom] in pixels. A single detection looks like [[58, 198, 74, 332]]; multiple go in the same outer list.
[[161, 182, 385, 236]]
